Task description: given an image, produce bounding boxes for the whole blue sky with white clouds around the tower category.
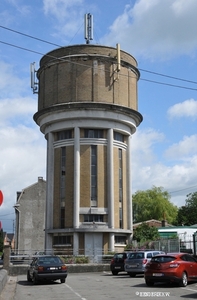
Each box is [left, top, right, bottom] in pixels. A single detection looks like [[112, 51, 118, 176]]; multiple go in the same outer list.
[[0, 0, 197, 233]]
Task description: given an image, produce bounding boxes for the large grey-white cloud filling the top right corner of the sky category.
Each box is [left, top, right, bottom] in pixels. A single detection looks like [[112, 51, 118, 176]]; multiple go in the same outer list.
[[102, 0, 197, 59]]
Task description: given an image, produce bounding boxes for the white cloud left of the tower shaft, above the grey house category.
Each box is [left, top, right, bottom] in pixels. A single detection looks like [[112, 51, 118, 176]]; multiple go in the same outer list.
[[0, 125, 46, 209]]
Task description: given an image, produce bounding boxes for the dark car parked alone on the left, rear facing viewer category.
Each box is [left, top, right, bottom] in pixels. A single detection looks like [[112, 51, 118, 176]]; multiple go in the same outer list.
[[27, 255, 67, 284]]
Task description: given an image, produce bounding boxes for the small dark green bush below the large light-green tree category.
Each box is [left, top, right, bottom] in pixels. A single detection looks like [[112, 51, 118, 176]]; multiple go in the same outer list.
[[133, 223, 159, 242]]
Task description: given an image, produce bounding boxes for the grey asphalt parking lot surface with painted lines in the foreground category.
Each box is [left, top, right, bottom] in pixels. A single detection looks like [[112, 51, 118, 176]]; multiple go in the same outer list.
[[0, 272, 197, 300]]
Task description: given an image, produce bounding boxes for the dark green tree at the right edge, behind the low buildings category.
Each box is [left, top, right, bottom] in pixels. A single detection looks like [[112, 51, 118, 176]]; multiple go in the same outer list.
[[176, 192, 197, 226]]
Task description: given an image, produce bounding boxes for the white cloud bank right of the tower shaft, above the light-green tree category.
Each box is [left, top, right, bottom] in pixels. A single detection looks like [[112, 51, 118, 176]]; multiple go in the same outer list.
[[132, 128, 197, 206]]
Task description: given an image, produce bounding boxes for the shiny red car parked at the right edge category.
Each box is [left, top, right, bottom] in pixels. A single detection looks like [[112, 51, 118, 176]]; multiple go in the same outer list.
[[144, 253, 197, 287]]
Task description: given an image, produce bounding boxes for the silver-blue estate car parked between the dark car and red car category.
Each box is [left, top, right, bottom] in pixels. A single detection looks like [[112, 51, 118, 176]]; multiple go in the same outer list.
[[125, 250, 164, 277]]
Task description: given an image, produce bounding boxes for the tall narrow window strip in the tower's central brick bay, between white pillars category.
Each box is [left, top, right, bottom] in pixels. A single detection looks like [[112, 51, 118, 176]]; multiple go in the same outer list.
[[91, 146, 97, 206]]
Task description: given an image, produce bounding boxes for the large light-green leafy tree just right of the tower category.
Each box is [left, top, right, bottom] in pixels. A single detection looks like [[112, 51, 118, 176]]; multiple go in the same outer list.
[[133, 186, 178, 224]]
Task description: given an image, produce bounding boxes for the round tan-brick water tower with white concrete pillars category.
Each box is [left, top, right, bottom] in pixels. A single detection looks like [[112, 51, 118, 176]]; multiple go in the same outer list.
[[34, 45, 142, 255]]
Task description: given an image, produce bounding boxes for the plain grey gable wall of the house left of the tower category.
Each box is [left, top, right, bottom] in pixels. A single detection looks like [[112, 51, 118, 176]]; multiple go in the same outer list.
[[14, 177, 46, 254]]
